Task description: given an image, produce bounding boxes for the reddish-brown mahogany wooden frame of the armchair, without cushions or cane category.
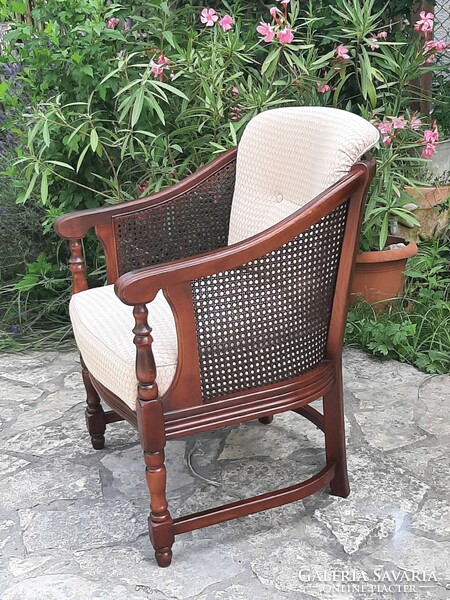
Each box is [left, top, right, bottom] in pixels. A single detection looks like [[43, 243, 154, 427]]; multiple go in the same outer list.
[[56, 149, 374, 566]]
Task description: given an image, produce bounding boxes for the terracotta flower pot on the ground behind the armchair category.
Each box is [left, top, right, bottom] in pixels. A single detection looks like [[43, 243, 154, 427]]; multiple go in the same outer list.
[[351, 236, 417, 310]]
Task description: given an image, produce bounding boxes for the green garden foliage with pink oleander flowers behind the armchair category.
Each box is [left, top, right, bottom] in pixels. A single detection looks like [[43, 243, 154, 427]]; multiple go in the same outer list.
[[0, 0, 450, 372]]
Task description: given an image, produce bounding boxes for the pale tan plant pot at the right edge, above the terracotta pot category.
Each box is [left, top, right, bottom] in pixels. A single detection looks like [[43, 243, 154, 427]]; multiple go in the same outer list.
[[398, 186, 450, 242]]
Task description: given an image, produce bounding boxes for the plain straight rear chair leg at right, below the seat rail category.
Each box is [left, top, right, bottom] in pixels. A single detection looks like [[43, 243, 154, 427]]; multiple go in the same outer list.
[[323, 375, 350, 498]]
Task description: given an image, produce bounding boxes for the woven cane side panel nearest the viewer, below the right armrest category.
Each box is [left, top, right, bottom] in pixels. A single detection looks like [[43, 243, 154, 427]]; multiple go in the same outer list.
[[192, 203, 348, 400]]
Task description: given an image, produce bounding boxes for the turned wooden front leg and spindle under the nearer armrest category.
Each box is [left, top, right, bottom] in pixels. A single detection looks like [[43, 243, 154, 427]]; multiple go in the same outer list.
[[133, 304, 174, 567]]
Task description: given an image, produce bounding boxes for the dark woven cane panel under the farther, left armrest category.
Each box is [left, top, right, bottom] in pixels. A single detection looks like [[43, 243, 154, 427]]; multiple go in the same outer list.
[[114, 161, 236, 274]]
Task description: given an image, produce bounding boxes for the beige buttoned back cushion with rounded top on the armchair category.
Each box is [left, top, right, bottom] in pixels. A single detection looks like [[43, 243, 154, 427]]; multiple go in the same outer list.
[[228, 106, 379, 244]]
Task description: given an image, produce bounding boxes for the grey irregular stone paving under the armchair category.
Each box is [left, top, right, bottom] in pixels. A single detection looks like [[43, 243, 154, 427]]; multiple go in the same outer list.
[[0, 350, 450, 600]]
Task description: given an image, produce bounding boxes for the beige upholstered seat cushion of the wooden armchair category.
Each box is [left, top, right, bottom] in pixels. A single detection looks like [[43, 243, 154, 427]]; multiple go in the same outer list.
[[70, 285, 178, 410]]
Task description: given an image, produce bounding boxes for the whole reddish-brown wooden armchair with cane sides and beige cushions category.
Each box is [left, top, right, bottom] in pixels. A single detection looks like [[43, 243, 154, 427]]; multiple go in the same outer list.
[[56, 107, 378, 566]]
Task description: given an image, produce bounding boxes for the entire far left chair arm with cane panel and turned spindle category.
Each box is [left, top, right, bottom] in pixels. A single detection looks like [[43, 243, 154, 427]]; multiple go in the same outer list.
[[55, 148, 237, 286]]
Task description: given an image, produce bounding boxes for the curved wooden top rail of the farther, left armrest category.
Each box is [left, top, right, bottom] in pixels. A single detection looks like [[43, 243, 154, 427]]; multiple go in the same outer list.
[[54, 148, 237, 240]]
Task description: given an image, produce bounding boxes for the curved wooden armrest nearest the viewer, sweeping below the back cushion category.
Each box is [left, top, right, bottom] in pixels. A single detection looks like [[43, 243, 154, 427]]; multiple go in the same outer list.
[[115, 161, 373, 305]]
